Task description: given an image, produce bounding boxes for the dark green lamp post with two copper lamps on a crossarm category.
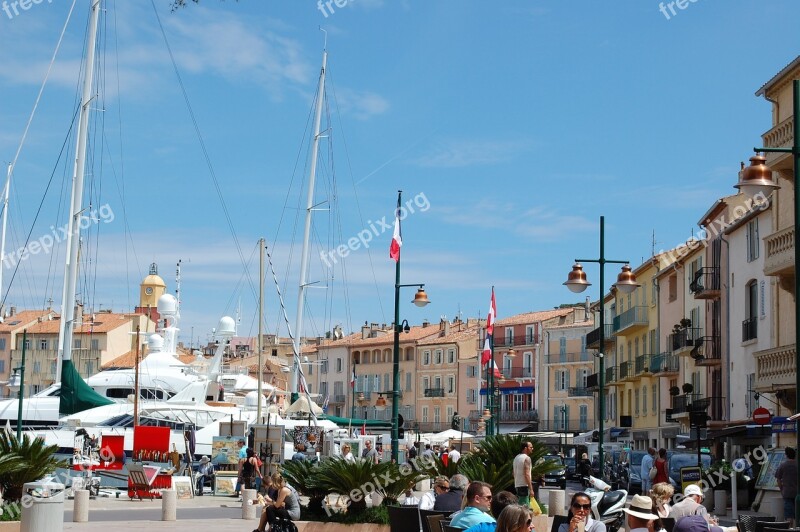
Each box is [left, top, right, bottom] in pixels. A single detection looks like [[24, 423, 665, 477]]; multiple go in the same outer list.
[[564, 216, 639, 474]]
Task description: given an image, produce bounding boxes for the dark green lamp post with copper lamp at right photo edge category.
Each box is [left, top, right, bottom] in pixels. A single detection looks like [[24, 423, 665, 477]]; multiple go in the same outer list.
[[736, 79, 800, 515]]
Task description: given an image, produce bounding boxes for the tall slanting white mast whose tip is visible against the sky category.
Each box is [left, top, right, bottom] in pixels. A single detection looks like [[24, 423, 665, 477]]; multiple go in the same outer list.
[[289, 49, 328, 402]]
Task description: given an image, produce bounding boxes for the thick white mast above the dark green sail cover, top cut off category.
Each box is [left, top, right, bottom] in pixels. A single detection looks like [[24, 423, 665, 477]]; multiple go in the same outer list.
[[55, 0, 102, 382]]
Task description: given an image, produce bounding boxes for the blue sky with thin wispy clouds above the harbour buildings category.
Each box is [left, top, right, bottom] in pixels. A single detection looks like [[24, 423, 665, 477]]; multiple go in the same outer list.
[[0, 0, 800, 348]]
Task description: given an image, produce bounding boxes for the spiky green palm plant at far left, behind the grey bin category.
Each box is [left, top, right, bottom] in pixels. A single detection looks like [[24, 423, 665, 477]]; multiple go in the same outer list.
[[0, 430, 67, 502]]
